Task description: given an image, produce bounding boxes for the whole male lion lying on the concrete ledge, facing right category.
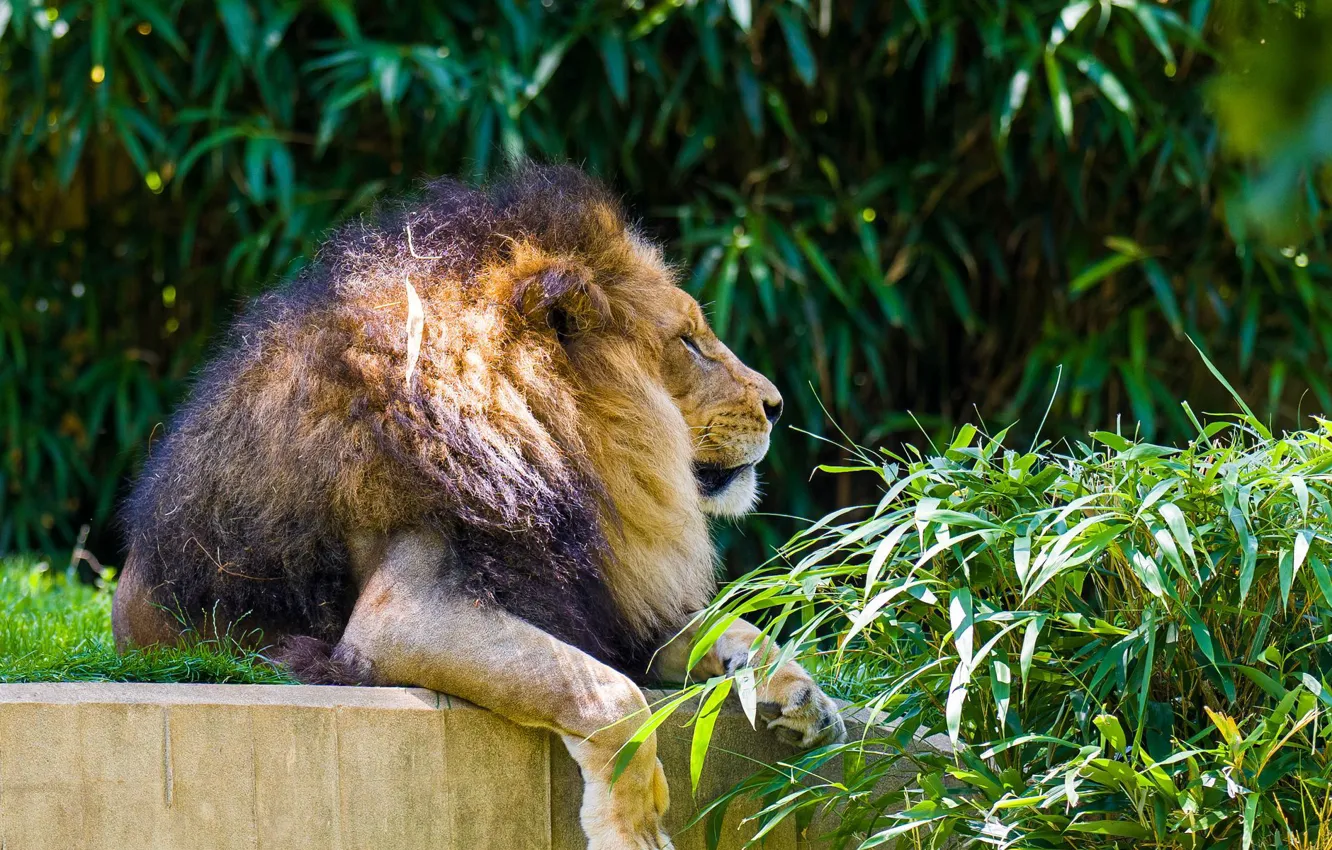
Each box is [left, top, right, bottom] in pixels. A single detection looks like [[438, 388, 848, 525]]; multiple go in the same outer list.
[[112, 165, 844, 850]]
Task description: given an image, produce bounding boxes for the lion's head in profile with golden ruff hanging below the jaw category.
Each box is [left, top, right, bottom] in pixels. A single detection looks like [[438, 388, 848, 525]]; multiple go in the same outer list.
[[482, 191, 782, 629]]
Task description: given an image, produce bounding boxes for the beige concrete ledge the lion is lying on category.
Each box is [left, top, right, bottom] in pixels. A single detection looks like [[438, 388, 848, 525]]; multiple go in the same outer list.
[[0, 683, 831, 850]]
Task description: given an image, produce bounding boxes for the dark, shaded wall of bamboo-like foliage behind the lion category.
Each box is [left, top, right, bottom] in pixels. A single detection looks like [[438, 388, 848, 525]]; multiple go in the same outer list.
[[0, 0, 1332, 570]]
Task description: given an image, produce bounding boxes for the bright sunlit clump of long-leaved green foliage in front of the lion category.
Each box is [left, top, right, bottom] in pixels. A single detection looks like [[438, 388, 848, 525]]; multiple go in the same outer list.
[[687, 406, 1332, 850]]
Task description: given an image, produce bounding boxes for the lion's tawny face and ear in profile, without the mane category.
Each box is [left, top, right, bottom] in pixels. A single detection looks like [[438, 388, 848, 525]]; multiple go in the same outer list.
[[503, 219, 782, 517]]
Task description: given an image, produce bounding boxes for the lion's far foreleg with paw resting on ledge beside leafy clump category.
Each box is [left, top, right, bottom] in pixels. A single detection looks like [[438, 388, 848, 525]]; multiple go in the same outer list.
[[651, 618, 846, 747]]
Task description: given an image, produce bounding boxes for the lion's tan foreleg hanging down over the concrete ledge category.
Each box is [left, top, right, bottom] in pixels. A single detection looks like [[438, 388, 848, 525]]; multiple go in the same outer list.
[[336, 534, 670, 850]]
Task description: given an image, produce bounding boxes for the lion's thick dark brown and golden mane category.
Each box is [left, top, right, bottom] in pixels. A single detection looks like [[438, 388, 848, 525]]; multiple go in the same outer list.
[[124, 167, 699, 679]]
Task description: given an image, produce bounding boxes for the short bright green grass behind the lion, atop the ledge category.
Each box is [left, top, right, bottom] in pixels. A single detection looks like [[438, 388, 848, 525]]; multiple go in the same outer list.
[[0, 557, 293, 685]]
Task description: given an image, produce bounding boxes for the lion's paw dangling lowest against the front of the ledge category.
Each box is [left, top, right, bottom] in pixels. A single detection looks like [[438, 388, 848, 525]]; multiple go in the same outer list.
[[582, 758, 671, 850]]
